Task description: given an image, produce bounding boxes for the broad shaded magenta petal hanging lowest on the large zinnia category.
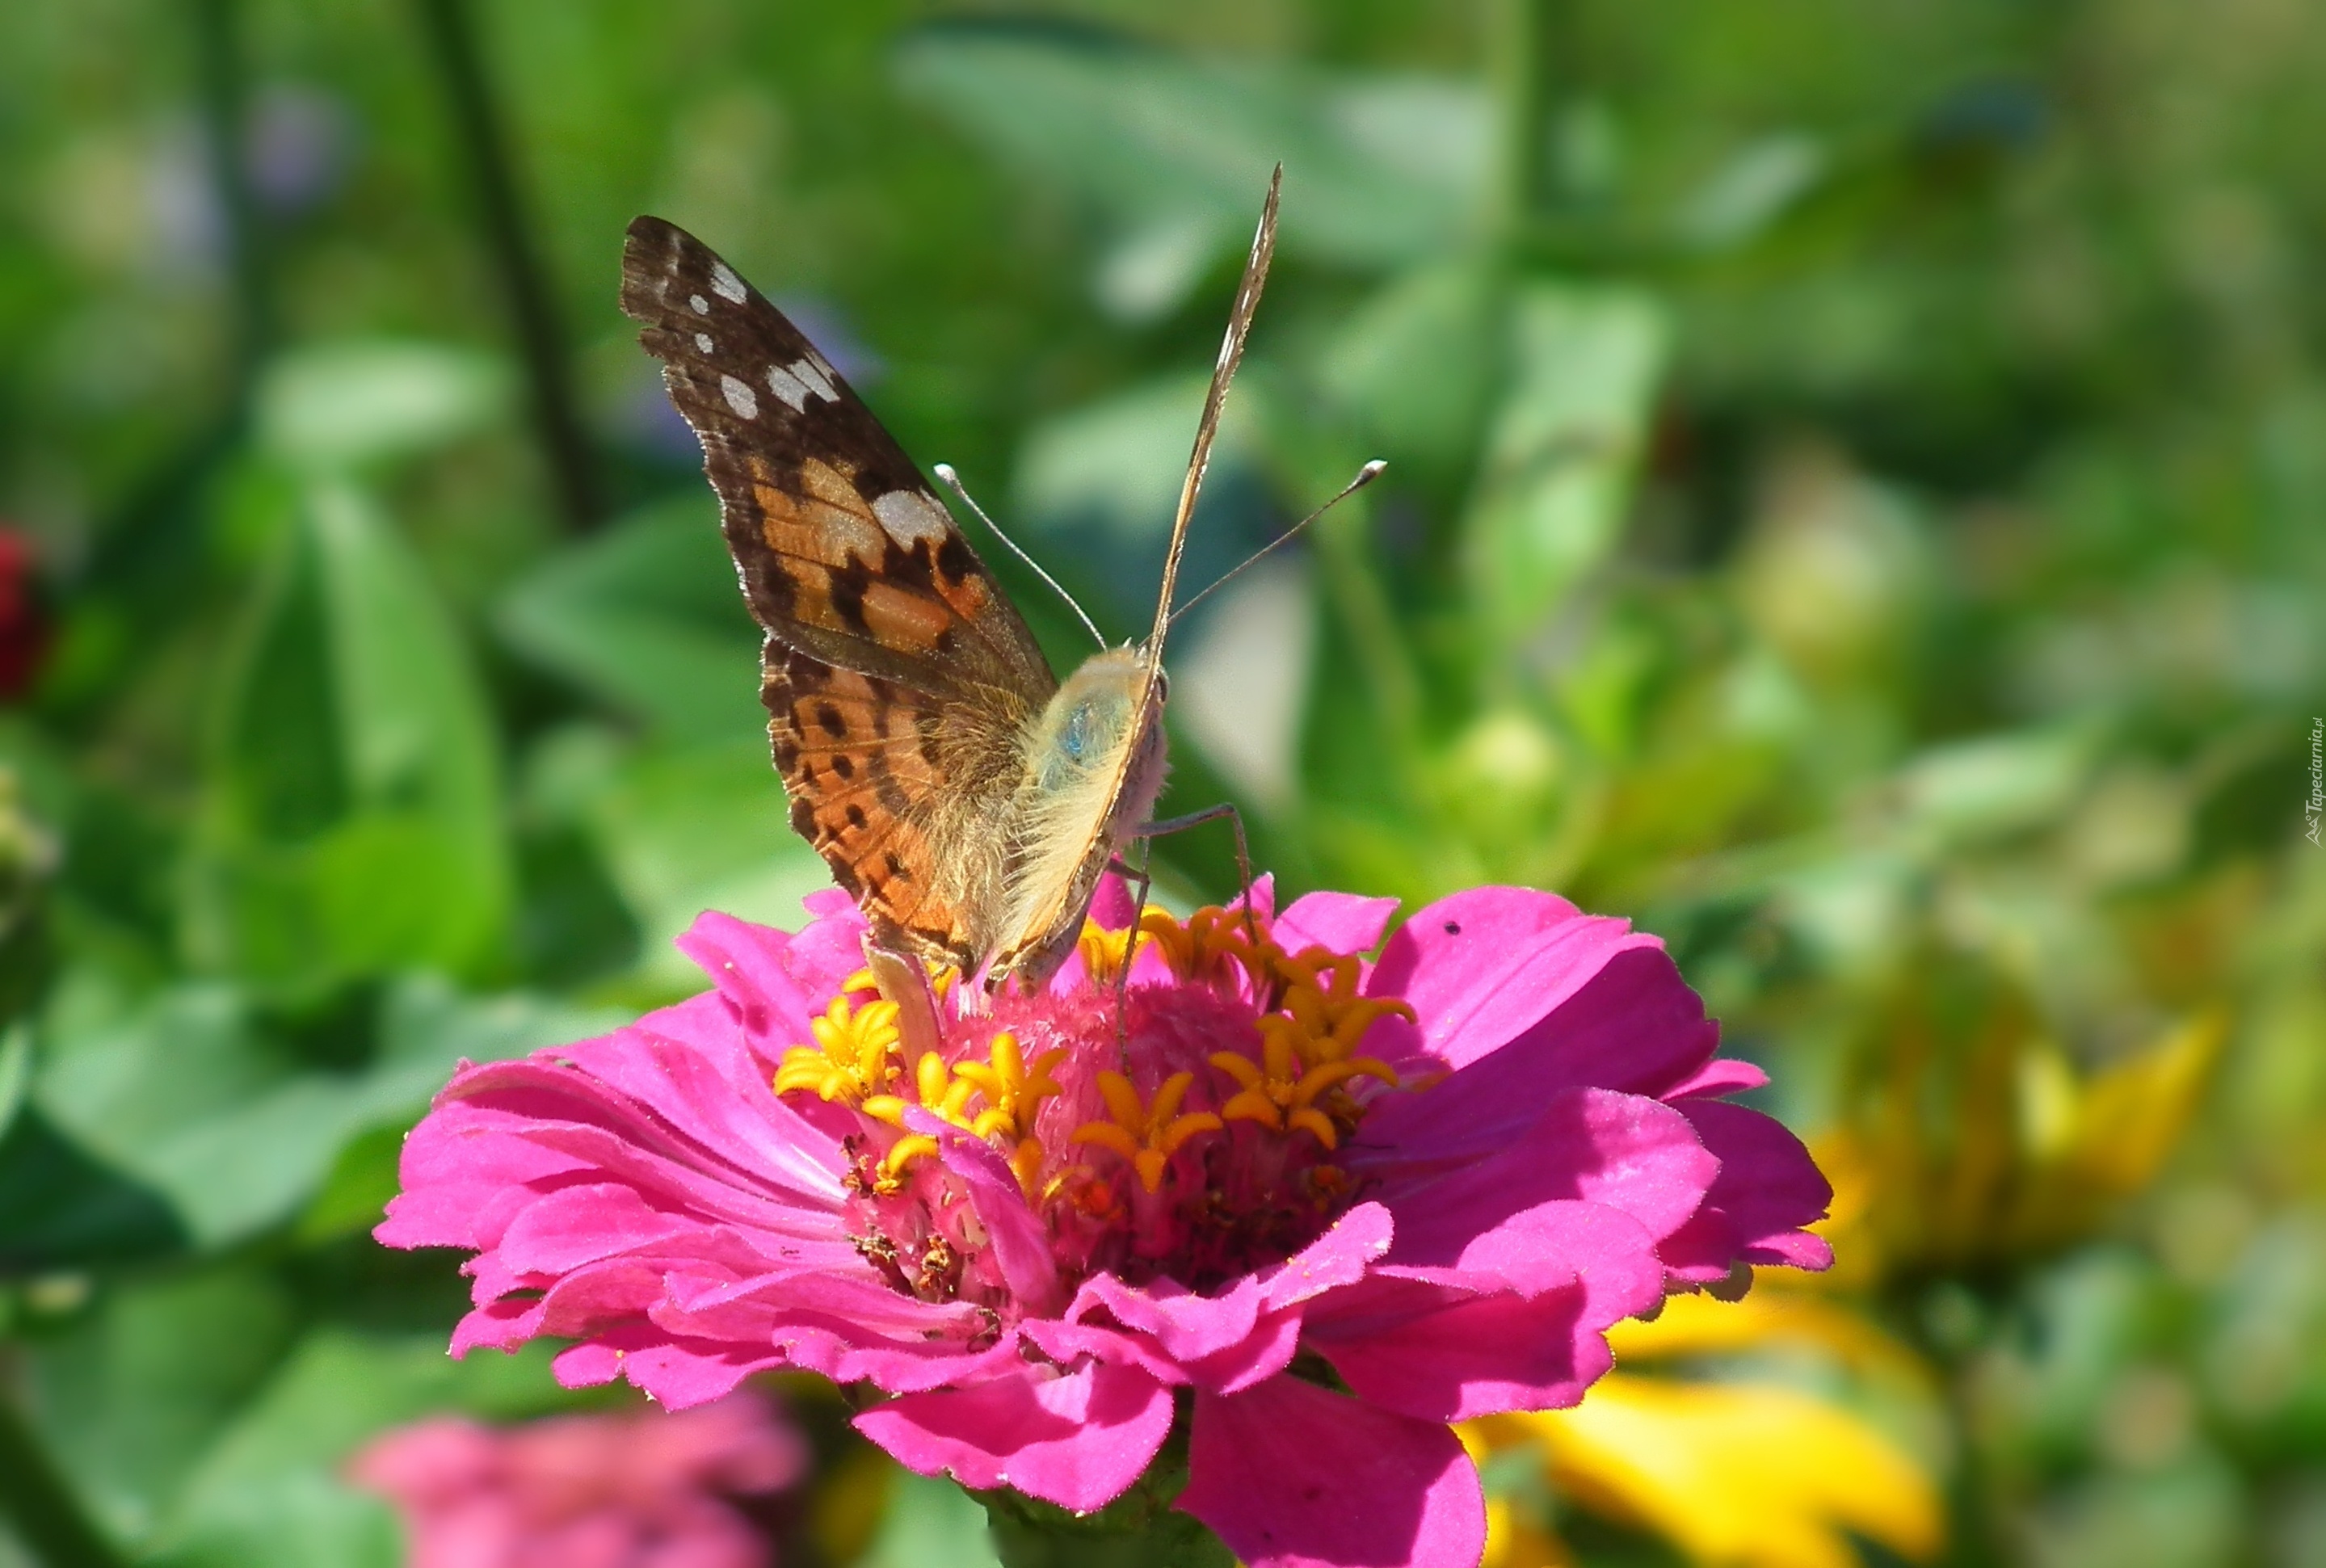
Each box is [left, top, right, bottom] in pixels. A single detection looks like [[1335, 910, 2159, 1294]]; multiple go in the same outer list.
[[1177, 1377, 1487, 1568]]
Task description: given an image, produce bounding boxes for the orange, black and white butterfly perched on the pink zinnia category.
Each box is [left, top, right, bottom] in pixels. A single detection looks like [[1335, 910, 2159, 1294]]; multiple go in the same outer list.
[[621, 165, 1284, 986]]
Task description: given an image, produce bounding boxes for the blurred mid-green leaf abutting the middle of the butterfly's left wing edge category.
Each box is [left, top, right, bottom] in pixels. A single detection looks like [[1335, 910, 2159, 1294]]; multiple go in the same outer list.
[[493, 494, 768, 740]]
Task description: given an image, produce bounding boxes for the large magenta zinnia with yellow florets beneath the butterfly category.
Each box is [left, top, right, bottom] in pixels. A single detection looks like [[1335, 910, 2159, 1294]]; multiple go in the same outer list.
[[379, 881, 1828, 1568]]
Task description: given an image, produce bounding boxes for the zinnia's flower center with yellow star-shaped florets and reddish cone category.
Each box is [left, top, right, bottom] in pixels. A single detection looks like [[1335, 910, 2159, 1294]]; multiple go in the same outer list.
[[775, 910, 1412, 1314]]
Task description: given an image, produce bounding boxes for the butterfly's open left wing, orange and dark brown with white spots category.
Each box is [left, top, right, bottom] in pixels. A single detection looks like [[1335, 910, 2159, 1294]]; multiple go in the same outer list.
[[621, 219, 1056, 968]]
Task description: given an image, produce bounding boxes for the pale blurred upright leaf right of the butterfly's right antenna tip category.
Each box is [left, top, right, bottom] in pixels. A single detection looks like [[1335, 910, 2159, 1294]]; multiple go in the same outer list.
[[1463, 284, 1665, 645]]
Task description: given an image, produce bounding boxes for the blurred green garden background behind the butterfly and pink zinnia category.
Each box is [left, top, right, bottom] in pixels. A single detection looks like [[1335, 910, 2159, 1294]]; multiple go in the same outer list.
[[0, 0, 2326, 1568]]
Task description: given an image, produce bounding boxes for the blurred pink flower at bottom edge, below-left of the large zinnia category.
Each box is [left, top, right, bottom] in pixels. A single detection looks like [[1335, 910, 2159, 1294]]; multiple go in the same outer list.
[[349, 1396, 807, 1568]]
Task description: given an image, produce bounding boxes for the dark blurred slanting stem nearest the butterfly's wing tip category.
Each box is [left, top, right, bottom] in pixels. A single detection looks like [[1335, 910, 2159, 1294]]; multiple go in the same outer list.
[[416, 0, 600, 532]]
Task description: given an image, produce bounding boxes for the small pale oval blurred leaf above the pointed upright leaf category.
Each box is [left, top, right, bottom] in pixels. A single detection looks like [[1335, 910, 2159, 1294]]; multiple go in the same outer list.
[[259, 342, 511, 468]]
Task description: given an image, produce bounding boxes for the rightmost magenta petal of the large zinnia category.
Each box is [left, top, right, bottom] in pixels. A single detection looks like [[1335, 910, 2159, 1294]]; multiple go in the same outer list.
[[1659, 1100, 1833, 1284]]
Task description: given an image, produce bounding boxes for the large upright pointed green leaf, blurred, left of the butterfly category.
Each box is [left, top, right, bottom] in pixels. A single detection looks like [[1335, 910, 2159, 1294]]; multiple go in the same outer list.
[[186, 481, 511, 994]]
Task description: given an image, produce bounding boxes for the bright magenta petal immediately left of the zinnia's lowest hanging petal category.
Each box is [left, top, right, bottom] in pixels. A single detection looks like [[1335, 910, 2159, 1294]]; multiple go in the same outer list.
[[856, 1361, 1170, 1515]]
